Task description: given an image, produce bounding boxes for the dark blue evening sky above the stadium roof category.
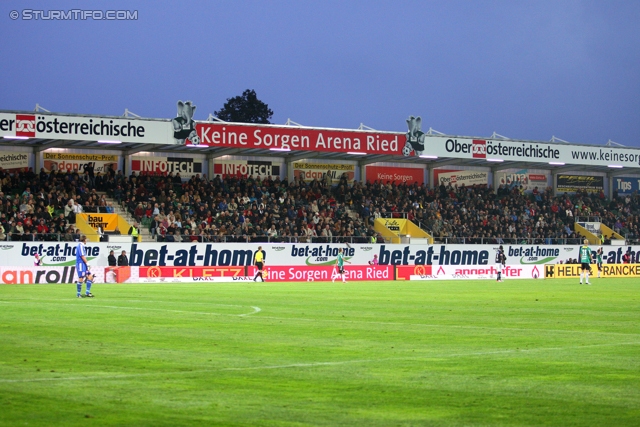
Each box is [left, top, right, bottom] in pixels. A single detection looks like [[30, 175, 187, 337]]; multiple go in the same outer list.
[[0, 0, 640, 146]]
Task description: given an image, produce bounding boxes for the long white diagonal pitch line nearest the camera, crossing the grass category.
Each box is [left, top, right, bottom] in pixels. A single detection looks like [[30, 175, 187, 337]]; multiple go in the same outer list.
[[0, 342, 640, 384]]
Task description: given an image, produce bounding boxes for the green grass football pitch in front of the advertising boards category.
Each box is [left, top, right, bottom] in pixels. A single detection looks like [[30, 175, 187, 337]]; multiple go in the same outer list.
[[0, 278, 640, 426]]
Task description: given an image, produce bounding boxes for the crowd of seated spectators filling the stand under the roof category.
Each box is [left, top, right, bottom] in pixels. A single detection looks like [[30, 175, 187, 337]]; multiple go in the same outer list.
[[0, 162, 640, 244]]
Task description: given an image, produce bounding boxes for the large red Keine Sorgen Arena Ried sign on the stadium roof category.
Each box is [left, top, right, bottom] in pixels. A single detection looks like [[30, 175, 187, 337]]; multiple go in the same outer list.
[[187, 123, 405, 155]]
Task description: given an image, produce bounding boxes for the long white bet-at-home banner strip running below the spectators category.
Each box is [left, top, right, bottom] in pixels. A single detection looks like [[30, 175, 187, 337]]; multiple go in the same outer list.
[[5, 242, 640, 268]]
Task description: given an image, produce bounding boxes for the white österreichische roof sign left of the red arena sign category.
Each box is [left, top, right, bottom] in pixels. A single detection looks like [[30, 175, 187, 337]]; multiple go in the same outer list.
[[0, 113, 175, 144]]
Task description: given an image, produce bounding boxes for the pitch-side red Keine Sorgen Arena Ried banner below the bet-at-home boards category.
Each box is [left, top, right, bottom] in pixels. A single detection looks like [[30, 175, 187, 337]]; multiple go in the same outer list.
[[248, 265, 394, 282]]
